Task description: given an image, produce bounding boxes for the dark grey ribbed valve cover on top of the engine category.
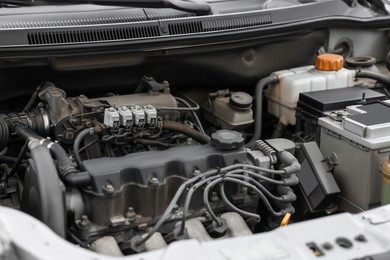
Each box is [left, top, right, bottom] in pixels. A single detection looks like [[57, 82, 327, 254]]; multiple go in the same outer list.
[[79, 145, 270, 225]]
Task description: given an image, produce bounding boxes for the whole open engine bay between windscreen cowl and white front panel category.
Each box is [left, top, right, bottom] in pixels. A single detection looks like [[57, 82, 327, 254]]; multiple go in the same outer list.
[[0, 1, 390, 256]]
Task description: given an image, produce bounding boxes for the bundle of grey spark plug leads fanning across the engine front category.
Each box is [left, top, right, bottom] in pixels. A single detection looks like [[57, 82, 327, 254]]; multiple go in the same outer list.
[[131, 148, 300, 252]]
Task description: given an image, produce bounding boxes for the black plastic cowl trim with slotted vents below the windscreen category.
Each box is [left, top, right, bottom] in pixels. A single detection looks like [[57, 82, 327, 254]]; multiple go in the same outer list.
[[0, 1, 390, 57]]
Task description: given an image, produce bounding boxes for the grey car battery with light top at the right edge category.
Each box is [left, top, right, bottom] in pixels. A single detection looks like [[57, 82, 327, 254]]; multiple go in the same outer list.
[[318, 100, 390, 210]]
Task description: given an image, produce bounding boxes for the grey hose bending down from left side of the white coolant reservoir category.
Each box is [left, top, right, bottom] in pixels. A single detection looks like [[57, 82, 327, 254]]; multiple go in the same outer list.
[[247, 75, 279, 146]]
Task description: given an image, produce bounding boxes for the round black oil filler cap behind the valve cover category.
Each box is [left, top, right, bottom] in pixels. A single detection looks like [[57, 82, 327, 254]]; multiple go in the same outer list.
[[211, 130, 245, 150]]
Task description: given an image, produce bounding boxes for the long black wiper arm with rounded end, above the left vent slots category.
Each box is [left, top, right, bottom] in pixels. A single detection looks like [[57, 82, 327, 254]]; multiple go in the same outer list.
[[53, 0, 211, 15]]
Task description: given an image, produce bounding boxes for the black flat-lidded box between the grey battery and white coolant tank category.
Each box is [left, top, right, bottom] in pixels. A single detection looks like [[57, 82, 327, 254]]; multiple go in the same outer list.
[[295, 86, 386, 143]]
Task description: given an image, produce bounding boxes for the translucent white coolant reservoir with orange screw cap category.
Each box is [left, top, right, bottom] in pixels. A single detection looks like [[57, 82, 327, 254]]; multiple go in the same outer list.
[[265, 54, 356, 125]]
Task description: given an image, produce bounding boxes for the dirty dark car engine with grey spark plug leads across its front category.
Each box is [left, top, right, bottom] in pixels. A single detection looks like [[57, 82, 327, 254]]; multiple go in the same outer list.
[[0, 74, 300, 252]]
